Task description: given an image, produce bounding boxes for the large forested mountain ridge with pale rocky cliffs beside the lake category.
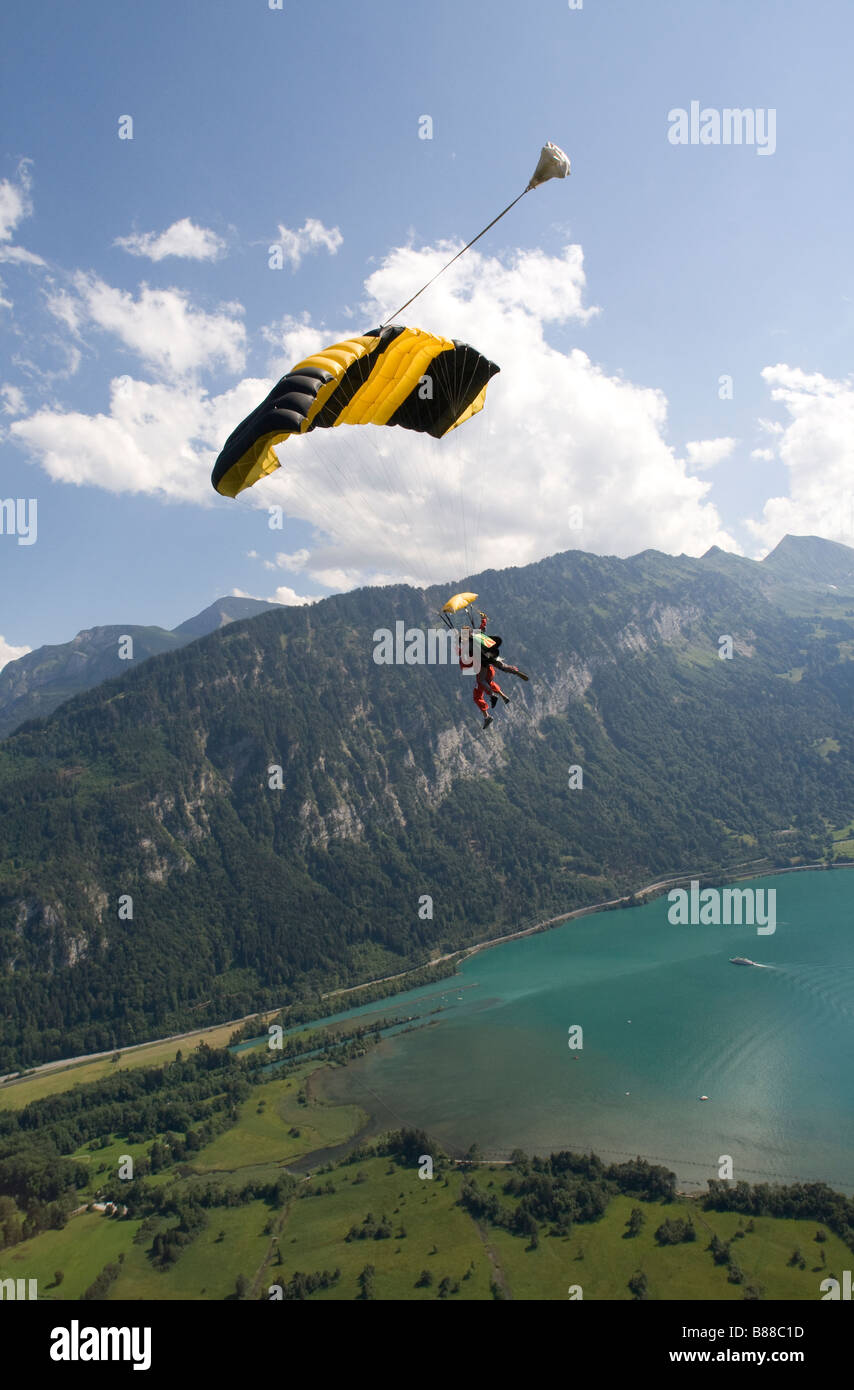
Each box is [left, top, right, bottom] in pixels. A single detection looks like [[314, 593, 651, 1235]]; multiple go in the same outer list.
[[0, 542, 854, 1072]]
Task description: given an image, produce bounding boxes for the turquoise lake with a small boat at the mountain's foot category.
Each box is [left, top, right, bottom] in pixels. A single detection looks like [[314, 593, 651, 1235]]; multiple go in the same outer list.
[[314, 869, 854, 1190]]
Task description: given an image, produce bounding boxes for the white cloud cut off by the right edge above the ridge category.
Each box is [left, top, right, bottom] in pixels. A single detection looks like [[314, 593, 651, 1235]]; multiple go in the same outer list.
[[747, 363, 854, 548]]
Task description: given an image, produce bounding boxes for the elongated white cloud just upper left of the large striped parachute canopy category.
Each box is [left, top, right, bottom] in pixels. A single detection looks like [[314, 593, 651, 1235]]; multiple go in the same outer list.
[[64, 271, 246, 377]]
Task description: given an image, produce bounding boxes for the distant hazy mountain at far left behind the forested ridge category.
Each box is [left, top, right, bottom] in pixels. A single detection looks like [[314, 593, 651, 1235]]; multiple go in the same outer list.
[[0, 598, 275, 738]]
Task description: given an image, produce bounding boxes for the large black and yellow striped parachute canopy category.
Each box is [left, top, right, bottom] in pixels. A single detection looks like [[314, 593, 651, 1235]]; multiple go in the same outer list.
[[210, 325, 499, 498]]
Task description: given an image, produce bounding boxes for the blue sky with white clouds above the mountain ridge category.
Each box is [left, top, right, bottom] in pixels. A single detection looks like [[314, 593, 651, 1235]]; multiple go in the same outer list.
[[0, 0, 854, 662]]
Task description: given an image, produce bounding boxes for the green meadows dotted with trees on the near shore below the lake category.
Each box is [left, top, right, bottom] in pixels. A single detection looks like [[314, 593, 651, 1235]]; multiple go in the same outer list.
[[0, 1044, 851, 1301]]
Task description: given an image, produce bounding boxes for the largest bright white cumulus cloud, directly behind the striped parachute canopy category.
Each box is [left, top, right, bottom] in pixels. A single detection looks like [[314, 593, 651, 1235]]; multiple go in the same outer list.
[[248, 245, 739, 588]]
